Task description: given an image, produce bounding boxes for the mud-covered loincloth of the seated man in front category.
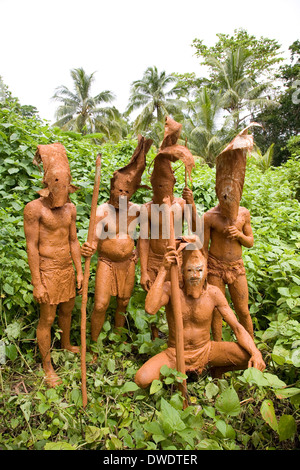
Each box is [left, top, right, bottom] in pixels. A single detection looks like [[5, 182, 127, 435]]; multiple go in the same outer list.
[[164, 342, 211, 374]]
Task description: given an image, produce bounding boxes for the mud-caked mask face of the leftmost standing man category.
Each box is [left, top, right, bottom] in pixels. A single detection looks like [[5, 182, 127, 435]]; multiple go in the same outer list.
[[45, 170, 70, 208]]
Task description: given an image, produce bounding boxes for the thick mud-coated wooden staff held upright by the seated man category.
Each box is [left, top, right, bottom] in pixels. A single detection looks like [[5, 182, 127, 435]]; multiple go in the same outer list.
[[169, 206, 188, 408]]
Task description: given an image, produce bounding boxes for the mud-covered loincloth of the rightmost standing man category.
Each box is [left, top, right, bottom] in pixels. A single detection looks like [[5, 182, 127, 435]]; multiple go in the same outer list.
[[207, 254, 246, 284]]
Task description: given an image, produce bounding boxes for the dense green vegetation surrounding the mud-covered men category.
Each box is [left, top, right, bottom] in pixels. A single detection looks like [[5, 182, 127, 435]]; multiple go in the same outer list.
[[0, 28, 300, 450]]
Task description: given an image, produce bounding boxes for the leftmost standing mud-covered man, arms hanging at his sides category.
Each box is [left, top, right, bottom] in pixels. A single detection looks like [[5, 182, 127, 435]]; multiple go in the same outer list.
[[24, 143, 83, 387]]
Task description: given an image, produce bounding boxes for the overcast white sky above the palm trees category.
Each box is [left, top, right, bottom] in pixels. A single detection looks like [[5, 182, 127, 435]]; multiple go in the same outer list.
[[0, 0, 300, 121]]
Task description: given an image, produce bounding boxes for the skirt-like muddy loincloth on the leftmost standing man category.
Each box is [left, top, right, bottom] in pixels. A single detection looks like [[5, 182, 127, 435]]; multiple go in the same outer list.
[[39, 256, 76, 305]]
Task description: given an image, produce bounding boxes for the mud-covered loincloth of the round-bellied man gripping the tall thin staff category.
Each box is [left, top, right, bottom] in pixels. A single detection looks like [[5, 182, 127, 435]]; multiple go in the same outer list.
[[98, 251, 137, 298]]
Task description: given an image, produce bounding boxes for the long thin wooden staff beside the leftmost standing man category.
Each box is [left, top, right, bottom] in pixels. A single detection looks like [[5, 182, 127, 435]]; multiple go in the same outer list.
[[81, 154, 101, 408]]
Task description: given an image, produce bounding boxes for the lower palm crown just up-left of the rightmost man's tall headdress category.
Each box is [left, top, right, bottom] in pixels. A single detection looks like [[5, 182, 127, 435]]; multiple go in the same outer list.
[[182, 86, 231, 166]]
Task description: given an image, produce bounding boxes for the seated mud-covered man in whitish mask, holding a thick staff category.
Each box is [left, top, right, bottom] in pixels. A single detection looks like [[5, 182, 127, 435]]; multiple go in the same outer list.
[[135, 239, 266, 388]]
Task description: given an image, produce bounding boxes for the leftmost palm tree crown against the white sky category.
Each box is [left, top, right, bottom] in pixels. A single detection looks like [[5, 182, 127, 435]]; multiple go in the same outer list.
[[52, 68, 122, 138]]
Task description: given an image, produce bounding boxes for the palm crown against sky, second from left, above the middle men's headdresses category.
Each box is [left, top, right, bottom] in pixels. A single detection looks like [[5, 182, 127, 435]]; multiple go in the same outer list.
[[126, 67, 182, 137]]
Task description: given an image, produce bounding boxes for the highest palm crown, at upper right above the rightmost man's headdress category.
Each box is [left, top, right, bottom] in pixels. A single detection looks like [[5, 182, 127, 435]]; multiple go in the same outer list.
[[207, 47, 275, 130]]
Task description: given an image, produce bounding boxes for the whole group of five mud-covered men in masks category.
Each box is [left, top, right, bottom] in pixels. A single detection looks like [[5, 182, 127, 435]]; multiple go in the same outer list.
[[24, 117, 265, 388]]
